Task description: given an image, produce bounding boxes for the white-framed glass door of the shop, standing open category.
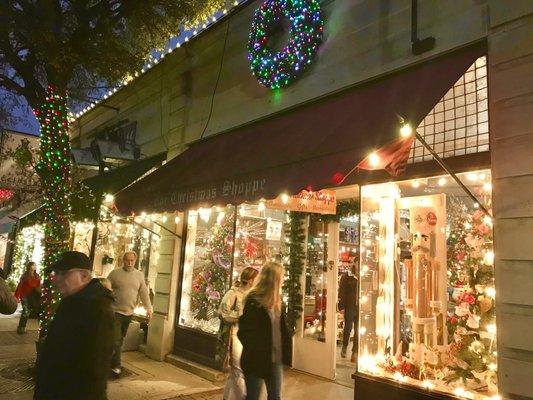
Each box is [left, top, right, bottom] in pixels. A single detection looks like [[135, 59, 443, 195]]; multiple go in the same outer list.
[[293, 218, 339, 380]]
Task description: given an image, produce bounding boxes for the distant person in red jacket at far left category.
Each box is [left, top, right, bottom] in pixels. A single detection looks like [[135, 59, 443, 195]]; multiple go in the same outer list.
[[15, 261, 41, 333]]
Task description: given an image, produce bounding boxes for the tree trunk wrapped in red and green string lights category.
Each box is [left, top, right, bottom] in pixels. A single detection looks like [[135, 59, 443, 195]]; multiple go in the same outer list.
[[34, 85, 72, 340]]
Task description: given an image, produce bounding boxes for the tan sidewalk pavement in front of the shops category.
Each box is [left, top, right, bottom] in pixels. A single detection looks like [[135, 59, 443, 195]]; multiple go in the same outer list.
[[0, 304, 353, 400]]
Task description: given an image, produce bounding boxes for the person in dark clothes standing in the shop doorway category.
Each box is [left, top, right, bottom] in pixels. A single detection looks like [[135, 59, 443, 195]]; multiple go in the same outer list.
[[339, 261, 359, 363]]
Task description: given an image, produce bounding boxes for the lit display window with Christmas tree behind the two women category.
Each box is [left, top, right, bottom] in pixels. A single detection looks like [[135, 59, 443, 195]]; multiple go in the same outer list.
[[178, 203, 286, 334]]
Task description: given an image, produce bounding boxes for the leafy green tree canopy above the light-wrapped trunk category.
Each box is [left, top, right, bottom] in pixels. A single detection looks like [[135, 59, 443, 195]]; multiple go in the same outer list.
[[0, 0, 225, 109]]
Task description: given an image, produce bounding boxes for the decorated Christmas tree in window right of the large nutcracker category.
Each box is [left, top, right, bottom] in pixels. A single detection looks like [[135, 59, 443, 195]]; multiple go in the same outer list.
[[446, 199, 496, 383]]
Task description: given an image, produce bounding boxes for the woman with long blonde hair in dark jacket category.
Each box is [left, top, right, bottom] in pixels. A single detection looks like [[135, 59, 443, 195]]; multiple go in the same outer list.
[[237, 262, 292, 400]]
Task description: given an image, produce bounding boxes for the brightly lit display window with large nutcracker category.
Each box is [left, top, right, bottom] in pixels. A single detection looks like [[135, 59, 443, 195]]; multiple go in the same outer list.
[[358, 171, 497, 399]]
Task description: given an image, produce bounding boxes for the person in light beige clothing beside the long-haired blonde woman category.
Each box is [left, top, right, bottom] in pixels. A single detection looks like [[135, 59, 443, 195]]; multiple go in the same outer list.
[[218, 267, 258, 400]]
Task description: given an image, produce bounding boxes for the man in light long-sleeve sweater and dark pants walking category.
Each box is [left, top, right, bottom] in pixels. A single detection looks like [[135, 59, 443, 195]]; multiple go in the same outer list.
[[107, 251, 152, 376]]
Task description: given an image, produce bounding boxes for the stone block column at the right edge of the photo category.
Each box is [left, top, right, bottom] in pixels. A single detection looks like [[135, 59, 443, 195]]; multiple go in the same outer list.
[[488, 0, 533, 399]]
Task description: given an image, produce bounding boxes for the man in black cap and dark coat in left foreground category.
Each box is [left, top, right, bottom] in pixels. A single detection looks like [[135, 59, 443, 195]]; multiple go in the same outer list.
[[34, 251, 114, 400]]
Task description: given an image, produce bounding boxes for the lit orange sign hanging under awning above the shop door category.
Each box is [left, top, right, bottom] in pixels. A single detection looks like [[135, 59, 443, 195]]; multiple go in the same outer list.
[[266, 189, 337, 214]]
